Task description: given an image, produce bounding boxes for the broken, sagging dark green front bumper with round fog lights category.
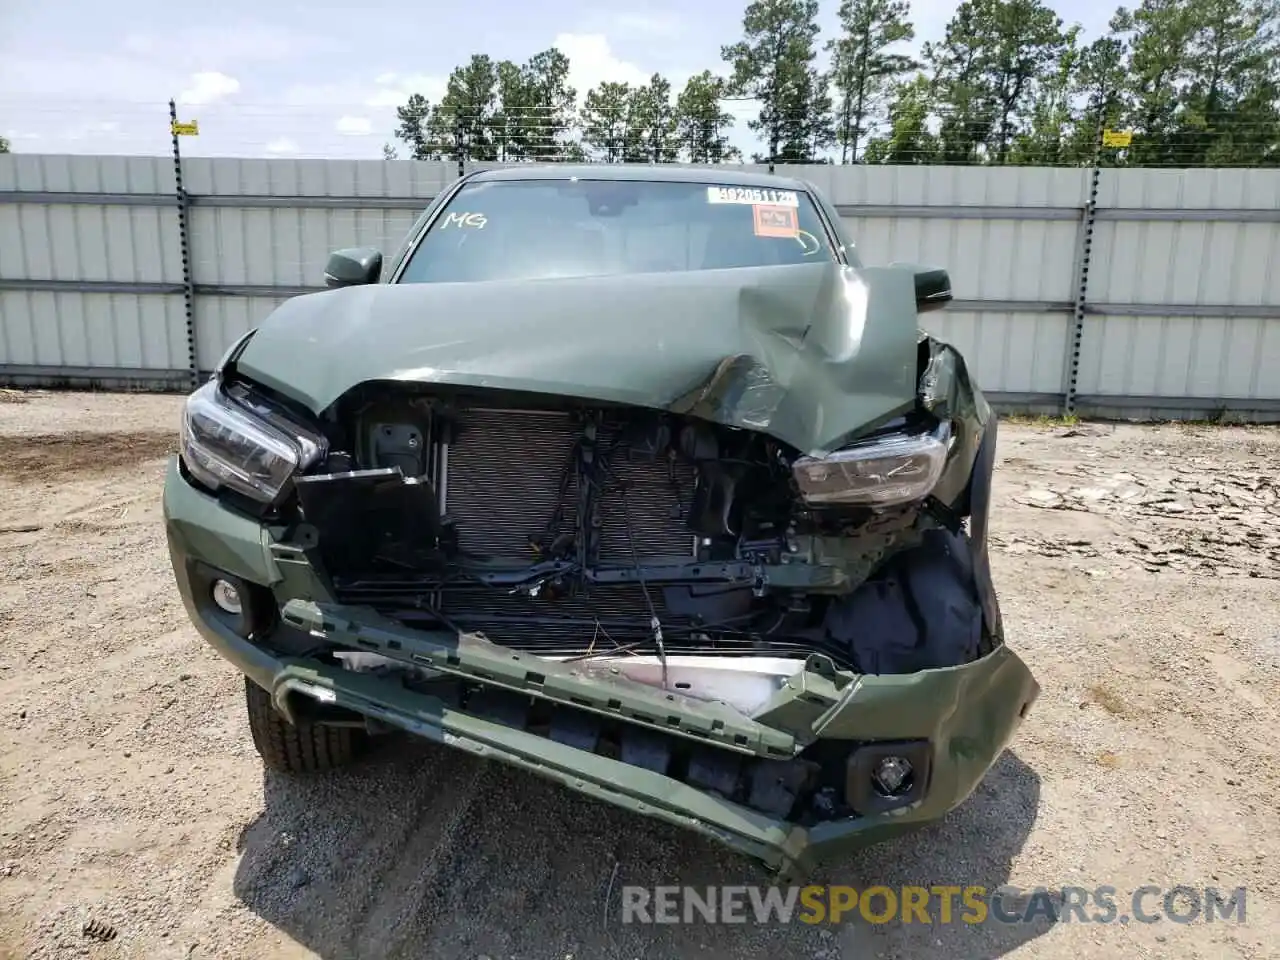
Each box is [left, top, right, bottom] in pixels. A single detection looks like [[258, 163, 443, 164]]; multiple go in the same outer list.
[[164, 461, 1039, 876]]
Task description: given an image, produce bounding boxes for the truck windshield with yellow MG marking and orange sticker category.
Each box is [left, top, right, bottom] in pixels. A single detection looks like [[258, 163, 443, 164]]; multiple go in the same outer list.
[[399, 180, 835, 283]]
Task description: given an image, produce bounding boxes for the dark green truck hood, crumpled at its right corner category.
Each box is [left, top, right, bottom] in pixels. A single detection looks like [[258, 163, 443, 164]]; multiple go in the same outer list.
[[236, 262, 918, 454]]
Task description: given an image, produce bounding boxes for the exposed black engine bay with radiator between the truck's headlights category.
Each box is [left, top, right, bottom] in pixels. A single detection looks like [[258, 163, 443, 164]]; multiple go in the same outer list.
[[270, 389, 972, 666]]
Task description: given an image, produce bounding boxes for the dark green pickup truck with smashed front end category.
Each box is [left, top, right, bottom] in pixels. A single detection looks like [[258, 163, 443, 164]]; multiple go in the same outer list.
[[164, 165, 1039, 876]]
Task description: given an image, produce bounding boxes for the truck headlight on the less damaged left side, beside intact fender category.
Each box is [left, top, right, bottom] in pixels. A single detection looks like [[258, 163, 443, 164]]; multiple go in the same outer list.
[[180, 380, 328, 503]]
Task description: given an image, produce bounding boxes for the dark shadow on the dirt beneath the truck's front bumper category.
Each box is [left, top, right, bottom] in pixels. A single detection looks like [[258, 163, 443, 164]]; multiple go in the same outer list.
[[236, 741, 1051, 960]]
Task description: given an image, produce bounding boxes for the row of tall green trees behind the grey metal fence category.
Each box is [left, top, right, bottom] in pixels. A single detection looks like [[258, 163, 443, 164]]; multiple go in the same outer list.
[[384, 0, 1280, 166]]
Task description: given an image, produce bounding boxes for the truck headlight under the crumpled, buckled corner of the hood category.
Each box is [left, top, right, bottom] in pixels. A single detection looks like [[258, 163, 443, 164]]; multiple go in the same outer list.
[[792, 424, 951, 506]]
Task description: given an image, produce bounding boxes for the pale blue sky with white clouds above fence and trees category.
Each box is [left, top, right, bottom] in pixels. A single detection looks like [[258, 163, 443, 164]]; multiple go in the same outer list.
[[0, 0, 1117, 159]]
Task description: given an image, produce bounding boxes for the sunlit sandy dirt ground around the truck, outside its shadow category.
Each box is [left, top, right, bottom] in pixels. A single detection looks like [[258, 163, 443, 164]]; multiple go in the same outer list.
[[0, 392, 1280, 960]]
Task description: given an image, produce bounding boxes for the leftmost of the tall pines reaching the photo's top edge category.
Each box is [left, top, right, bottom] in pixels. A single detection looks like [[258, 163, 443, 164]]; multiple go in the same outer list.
[[721, 0, 833, 163]]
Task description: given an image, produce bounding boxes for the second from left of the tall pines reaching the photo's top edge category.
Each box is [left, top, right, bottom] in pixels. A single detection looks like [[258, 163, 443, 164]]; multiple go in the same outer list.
[[827, 0, 918, 163]]
